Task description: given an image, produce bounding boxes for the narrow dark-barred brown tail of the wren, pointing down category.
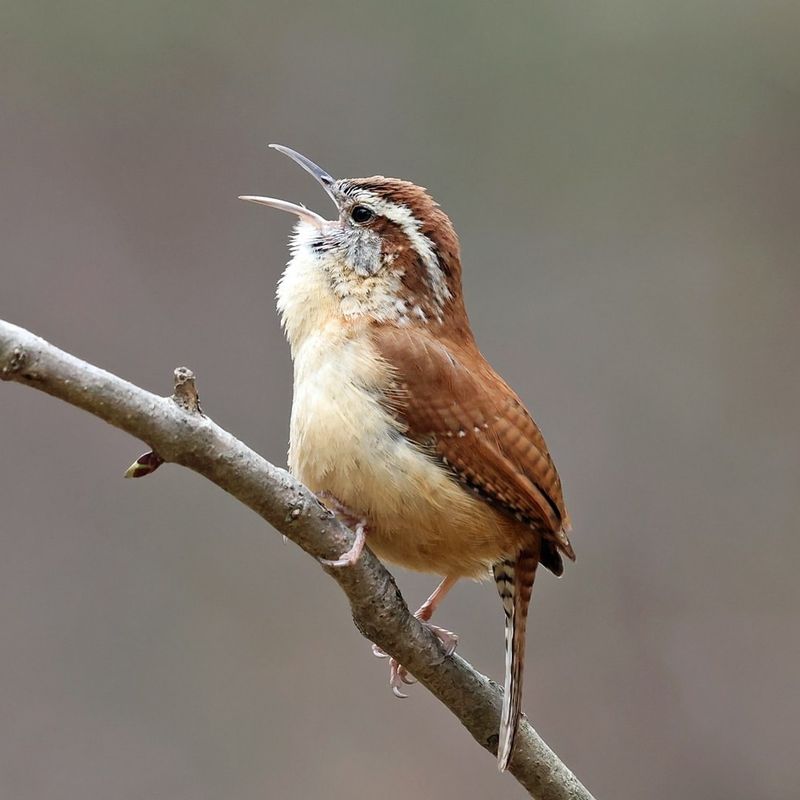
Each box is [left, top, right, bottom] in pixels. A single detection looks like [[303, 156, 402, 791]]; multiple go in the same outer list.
[[493, 548, 539, 772]]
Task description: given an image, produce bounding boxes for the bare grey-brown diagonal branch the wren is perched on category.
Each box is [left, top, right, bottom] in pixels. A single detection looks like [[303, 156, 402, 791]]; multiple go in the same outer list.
[[0, 320, 593, 800]]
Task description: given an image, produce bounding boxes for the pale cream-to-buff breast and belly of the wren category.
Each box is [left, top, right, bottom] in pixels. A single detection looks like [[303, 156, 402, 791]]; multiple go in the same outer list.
[[289, 328, 516, 578]]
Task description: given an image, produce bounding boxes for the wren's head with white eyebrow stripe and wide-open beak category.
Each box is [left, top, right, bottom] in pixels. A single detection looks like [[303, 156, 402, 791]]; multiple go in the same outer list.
[[241, 145, 463, 326]]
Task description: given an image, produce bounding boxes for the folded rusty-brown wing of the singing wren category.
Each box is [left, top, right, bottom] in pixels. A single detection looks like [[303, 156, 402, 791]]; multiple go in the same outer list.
[[374, 326, 575, 574]]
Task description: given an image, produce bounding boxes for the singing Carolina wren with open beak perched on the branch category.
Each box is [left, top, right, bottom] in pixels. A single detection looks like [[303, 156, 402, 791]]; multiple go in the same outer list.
[[242, 145, 575, 770]]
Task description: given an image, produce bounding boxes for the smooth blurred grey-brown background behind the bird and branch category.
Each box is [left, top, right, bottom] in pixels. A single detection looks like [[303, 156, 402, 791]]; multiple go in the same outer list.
[[0, 0, 800, 800]]
